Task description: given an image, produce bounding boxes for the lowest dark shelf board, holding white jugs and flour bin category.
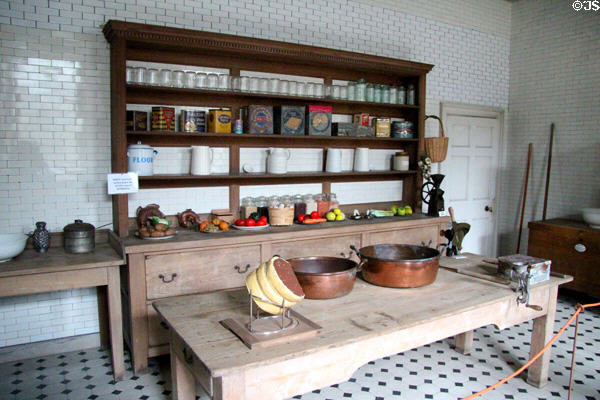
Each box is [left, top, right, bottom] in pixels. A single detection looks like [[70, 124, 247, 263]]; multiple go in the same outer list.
[[139, 171, 417, 189]]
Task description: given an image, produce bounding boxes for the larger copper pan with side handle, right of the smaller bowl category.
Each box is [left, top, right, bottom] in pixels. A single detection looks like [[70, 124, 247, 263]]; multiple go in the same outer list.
[[350, 244, 440, 288]]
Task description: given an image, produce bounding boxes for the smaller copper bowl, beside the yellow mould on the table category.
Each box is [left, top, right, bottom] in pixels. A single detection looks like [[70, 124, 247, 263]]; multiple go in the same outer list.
[[287, 257, 358, 299]]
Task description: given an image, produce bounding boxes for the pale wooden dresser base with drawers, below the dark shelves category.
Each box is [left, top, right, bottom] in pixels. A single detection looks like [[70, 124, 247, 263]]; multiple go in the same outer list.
[[121, 214, 450, 373]]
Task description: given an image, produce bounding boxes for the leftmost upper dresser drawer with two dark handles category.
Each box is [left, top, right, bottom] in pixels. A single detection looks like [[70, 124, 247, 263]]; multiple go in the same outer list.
[[146, 245, 260, 300]]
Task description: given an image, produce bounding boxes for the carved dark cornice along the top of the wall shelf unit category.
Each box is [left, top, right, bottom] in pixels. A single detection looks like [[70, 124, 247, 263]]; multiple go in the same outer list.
[[103, 20, 433, 76]]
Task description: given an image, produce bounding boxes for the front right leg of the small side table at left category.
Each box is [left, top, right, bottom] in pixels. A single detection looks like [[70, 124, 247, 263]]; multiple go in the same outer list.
[[106, 266, 125, 380]]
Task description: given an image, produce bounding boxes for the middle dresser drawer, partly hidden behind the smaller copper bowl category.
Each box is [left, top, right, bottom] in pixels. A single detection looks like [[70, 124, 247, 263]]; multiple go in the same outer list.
[[271, 234, 360, 258]]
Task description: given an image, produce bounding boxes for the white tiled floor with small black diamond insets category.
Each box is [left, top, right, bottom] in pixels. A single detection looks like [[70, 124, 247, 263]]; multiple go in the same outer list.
[[0, 295, 600, 400]]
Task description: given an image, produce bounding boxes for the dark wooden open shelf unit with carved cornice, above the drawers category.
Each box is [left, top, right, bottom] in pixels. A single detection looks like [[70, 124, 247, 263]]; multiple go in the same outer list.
[[104, 21, 433, 237]]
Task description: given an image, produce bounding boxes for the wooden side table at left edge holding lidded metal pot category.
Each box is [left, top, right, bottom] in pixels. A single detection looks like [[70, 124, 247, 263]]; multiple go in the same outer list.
[[0, 234, 125, 380]]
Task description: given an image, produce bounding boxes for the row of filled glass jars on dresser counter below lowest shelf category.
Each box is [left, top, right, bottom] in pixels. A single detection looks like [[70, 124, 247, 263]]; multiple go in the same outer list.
[[240, 193, 339, 220]]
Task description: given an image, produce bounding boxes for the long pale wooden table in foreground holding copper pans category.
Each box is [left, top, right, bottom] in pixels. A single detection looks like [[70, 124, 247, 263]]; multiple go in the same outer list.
[[154, 255, 571, 400]]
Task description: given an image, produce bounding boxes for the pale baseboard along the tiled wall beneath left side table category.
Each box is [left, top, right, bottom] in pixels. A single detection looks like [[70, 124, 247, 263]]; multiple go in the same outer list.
[[0, 333, 100, 364]]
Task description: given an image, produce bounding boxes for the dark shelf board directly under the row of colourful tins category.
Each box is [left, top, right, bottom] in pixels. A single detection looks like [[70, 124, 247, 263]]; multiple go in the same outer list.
[[127, 131, 419, 149]]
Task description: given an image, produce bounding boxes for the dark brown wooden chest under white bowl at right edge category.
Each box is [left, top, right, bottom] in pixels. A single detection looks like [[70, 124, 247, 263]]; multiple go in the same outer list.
[[527, 218, 600, 297]]
